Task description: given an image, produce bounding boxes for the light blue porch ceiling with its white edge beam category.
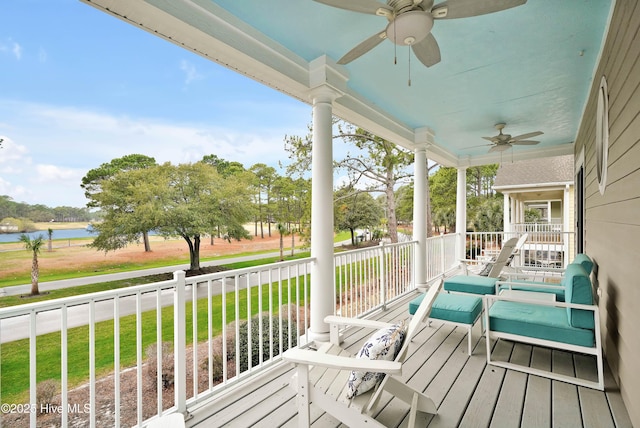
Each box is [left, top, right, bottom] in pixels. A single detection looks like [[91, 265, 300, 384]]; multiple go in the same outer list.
[[81, 0, 611, 166]]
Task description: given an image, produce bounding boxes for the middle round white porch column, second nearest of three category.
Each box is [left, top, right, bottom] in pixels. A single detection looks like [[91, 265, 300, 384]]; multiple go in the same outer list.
[[413, 147, 427, 287]]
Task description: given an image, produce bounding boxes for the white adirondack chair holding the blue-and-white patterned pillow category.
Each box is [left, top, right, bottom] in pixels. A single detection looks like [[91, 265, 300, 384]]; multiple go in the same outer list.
[[283, 281, 442, 428]]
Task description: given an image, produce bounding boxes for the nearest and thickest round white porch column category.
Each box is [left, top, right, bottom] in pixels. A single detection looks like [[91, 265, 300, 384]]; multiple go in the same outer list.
[[308, 86, 338, 341]]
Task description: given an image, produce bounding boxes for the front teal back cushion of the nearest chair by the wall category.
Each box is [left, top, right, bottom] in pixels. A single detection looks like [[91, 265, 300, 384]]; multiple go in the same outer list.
[[562, 264, 595, 329]]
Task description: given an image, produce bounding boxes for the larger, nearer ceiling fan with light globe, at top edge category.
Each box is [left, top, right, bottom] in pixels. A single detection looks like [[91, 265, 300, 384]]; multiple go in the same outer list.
[[315, 0, 527, 67]]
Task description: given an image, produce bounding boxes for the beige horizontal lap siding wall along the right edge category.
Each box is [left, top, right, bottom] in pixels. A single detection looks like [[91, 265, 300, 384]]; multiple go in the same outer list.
[[575, 0, 640, 426]]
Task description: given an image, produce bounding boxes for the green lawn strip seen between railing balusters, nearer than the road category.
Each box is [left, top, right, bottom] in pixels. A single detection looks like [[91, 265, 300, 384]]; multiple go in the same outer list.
[[0, 278, 310, 403]]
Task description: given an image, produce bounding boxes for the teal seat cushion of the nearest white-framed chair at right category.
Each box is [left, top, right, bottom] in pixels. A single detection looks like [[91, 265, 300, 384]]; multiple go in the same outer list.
[[489, 301, 595, 347]]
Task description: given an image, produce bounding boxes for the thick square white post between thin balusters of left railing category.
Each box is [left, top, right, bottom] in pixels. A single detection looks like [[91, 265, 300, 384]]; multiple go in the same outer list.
[[174, 270, 187, 414]]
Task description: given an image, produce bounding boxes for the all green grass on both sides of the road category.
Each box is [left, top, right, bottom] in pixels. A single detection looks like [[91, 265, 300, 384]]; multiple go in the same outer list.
[[0, 232, 350, 403]]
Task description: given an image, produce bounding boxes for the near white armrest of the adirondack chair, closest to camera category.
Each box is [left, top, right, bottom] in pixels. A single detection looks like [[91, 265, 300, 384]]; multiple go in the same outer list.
[[282, 348, 402, 374]]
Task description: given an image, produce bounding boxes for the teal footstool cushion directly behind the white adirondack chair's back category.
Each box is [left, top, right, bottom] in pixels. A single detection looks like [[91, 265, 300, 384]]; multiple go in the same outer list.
[[409, 293, 482, 324]]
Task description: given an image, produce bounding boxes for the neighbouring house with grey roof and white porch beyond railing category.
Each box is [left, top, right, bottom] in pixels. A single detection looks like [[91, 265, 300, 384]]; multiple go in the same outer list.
[[493, 155, 575, 267]]
